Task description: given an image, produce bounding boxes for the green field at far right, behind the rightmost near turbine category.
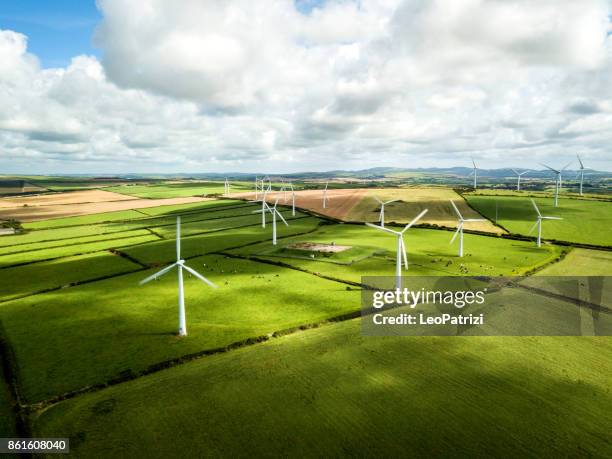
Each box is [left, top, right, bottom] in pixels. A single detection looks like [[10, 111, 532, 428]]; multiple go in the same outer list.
[[466, 196, 612, 246]]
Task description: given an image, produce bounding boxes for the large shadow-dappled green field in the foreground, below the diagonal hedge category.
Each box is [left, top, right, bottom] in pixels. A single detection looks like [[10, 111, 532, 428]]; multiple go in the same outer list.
[[34, 320, 612, 457]]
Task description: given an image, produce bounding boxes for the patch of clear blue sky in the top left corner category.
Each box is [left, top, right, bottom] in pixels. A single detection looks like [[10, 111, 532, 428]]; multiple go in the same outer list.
[[0, 0, 102, 67]]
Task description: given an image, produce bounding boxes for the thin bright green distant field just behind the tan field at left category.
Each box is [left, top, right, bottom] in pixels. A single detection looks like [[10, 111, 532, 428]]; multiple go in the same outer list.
[[106, 181, 253, 199]]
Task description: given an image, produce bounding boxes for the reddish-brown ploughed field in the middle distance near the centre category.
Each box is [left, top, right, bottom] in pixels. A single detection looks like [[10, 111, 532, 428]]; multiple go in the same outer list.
[[230, 188, 368, 220]]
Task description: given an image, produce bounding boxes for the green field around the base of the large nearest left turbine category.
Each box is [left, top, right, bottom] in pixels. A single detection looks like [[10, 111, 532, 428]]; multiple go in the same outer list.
[[0, 255, 359, 402]]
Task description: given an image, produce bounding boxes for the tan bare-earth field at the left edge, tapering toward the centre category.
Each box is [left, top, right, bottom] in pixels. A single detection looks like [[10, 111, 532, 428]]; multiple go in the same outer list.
[[0, 190, 209, 222]]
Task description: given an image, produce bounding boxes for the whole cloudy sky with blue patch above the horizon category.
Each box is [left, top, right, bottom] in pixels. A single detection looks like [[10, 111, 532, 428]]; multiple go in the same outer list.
[[0, 0, 612, 174]]
